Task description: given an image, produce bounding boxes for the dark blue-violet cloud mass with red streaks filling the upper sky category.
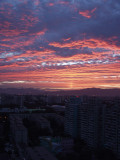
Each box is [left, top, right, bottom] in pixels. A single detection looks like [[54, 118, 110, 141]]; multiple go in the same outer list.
[[0, 0, 120, 57]]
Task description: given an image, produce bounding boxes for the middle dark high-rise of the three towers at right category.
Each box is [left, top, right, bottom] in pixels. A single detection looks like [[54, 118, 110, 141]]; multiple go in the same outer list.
[[78, 97, 103, 148]]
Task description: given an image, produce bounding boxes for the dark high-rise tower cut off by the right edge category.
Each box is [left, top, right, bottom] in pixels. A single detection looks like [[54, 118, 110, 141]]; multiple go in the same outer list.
[[103, 99, 120, 156]]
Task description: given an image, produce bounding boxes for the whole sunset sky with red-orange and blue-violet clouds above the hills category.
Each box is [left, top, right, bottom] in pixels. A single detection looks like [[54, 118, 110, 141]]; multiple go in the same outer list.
[[0, 0, 120, 90]]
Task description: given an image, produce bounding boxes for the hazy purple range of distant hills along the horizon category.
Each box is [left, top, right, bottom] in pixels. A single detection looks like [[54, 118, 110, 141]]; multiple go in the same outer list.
[[0, 88, 120, 96]]
